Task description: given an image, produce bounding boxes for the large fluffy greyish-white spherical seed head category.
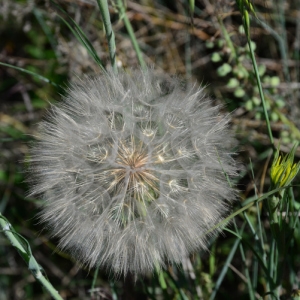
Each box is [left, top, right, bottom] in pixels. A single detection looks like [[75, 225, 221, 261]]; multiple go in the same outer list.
[[29, 70, 237, 275]]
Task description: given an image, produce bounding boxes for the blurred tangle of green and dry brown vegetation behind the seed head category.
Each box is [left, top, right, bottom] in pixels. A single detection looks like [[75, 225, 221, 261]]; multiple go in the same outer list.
[[0, 0, 300, 300]]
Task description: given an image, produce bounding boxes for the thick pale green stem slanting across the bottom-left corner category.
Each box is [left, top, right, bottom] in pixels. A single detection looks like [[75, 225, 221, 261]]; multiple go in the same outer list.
[[0, 213, 63, 300]]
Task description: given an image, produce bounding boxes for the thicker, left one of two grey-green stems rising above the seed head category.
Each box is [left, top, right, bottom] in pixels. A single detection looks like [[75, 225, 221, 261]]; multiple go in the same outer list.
[[97, 0, 118, 74]]
